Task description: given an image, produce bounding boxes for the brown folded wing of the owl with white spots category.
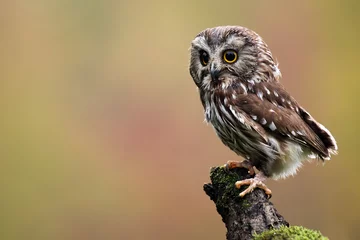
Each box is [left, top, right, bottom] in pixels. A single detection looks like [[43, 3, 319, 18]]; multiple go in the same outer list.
[[232, 82, 329, 158]]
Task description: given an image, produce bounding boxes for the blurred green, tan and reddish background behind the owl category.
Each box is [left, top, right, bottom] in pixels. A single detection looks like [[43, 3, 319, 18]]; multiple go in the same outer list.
[[0, 0, 360, 240]]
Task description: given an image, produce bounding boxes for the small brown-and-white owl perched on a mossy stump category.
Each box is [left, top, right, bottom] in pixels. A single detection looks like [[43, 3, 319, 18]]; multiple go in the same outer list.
[[189, 26, 337, 197]]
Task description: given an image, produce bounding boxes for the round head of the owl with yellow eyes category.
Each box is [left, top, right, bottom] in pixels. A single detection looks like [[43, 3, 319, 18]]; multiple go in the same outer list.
[[189, 26, 281, 91]]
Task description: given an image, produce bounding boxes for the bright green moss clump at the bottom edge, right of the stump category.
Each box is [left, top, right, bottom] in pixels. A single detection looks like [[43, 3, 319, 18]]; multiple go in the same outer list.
[[254, 226, 328, 240]]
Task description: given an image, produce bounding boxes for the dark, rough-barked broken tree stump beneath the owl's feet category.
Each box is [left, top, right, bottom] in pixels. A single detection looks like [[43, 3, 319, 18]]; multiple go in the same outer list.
[[204, 167, 289, 240]]
